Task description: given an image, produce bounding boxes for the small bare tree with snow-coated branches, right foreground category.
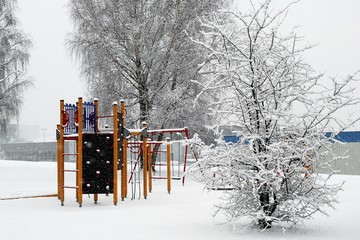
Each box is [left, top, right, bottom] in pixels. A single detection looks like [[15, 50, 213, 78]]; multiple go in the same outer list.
[[191, 0, 359, 229]]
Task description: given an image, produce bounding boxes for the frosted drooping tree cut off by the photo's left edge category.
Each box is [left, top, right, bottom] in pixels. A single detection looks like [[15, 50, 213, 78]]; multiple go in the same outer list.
[[0, 0, 31, 135]]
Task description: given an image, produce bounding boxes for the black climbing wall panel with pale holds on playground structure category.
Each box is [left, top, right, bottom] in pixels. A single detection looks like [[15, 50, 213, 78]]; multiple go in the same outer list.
[[82, 134, 113, 194]]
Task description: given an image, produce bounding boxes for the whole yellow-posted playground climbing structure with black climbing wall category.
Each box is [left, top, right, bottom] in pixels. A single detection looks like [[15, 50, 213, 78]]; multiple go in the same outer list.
[[57, 98, 196, 207]]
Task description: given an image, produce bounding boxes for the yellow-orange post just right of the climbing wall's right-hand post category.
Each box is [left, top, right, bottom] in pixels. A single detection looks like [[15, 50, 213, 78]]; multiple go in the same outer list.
[[119, 99, 127, 200]]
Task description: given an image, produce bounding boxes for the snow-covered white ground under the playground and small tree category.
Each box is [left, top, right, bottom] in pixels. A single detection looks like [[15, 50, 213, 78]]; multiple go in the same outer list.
[[0, 160, 360, 240]]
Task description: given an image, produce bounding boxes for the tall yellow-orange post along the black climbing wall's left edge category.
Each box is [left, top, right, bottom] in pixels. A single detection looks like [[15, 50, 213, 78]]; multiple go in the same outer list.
[[76, 97, 83, 207]]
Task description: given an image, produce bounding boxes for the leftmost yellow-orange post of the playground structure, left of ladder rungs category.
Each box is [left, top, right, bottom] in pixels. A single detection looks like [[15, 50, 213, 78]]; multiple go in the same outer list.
[[58, 100, 65, 206]]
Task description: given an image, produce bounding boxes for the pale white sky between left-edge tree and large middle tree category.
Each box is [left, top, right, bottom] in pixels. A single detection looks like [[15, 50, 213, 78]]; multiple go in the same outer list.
[[17, 0, 84, 139]]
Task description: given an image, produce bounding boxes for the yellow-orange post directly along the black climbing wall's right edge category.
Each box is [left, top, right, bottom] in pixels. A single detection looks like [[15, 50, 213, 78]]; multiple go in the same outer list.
[[113, 102, 119, 205]]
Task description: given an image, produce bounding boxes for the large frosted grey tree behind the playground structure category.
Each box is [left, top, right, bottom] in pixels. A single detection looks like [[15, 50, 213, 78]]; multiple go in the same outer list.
[[69, 0, 224, 141]]
